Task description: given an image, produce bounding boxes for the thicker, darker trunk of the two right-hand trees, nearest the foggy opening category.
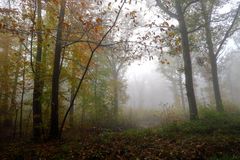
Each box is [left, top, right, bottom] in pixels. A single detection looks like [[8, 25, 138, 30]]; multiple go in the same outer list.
[[175, 0, 198, 120]]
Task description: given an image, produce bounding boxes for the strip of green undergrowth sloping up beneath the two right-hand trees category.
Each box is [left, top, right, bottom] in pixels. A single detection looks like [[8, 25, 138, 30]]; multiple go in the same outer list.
[[117, 108, 240, 138]]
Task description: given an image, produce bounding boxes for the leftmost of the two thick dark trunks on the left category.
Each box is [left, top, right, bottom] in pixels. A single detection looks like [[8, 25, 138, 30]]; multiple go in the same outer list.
[[32, 0, 43, 141]]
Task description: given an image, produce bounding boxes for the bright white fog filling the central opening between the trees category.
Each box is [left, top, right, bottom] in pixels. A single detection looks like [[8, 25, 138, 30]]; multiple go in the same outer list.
[[125, 60, 173, 108]]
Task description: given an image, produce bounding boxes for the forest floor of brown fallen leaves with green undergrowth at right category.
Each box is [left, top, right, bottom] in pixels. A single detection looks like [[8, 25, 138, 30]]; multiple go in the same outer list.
[[0, 110, 240, 160]]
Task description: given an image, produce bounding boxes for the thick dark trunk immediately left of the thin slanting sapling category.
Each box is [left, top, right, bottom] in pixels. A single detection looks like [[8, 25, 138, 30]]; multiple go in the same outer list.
[[49, 0, 66, 139]]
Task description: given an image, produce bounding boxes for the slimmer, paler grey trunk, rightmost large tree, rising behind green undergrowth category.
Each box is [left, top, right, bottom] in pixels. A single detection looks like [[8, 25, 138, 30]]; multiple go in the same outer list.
[[201, 0, 224, 112]]
